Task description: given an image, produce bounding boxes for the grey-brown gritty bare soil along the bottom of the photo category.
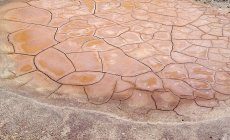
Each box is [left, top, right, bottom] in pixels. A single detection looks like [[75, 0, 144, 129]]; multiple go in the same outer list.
[[0, 89, 230, 140]]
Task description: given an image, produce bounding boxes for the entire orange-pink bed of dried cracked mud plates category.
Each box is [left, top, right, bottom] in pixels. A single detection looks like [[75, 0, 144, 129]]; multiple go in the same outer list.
[[0, 0, 230, 118]]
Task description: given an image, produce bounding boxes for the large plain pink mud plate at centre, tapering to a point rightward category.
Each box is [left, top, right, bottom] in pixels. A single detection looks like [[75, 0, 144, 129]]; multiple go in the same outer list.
[[100, 50, 150, 76]]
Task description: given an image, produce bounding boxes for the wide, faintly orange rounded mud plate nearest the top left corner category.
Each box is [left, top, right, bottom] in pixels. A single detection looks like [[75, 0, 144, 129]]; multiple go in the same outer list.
[[4, 6, 51, 25]]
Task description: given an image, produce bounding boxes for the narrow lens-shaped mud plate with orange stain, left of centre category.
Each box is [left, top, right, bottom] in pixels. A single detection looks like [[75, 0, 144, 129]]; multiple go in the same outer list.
[[59, 72, 104, 86]]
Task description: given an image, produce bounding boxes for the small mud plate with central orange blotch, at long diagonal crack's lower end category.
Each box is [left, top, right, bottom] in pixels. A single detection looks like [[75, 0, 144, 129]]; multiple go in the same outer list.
[[136, 72, 163, 91]]
